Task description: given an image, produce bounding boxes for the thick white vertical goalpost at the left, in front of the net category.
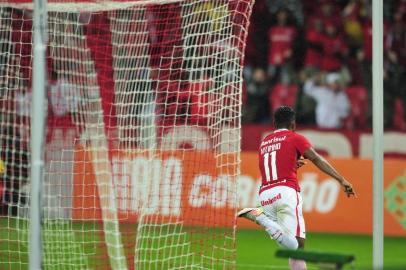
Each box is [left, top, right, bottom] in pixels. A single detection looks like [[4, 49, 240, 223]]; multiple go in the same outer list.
[[28, 0, 48, 270]]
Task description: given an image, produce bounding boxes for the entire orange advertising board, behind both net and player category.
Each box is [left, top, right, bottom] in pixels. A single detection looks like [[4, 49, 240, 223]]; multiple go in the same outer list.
[[73, 150, 406, 235]]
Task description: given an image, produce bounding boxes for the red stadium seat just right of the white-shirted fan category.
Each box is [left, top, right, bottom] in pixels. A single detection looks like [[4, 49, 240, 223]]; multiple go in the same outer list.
[[345, 85, 368, 128]]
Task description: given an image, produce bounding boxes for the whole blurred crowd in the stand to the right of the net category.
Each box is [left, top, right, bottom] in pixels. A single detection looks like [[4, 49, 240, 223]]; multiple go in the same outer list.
[[243, 0, 406, 130]]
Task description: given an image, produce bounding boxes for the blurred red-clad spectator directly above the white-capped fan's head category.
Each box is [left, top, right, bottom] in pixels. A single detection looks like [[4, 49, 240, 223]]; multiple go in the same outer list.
[[321, 23, 348, 72]]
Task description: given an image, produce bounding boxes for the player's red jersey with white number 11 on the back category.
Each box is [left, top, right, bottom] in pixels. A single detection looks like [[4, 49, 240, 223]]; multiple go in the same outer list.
[[259, 129, 311, 193]]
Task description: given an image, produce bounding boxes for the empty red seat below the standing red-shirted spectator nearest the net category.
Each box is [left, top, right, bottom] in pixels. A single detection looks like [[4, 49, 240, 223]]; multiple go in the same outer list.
[[269, 83, 298, 111]]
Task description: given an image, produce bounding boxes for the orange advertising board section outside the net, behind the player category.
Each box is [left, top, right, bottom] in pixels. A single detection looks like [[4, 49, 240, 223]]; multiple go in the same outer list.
[[239, 153, 406, 236]]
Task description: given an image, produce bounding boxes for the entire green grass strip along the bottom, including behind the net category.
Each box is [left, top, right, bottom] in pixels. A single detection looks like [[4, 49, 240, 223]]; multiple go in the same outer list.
[[0, 217, 406, 270]]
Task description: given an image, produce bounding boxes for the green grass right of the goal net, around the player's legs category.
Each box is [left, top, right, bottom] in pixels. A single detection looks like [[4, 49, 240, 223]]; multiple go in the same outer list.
[[237, 229, 406, 270]]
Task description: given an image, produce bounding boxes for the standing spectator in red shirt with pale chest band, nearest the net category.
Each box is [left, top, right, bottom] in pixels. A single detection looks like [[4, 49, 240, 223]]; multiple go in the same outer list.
[[268, 9, 297, 84]]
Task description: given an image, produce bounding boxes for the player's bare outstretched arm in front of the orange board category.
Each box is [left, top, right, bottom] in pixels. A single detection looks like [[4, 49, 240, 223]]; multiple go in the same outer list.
[[303, 147, 357, 197]]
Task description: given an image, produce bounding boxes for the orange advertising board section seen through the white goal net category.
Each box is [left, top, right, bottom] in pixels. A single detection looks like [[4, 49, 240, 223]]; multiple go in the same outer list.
[[73, 150, 236, 227]]
